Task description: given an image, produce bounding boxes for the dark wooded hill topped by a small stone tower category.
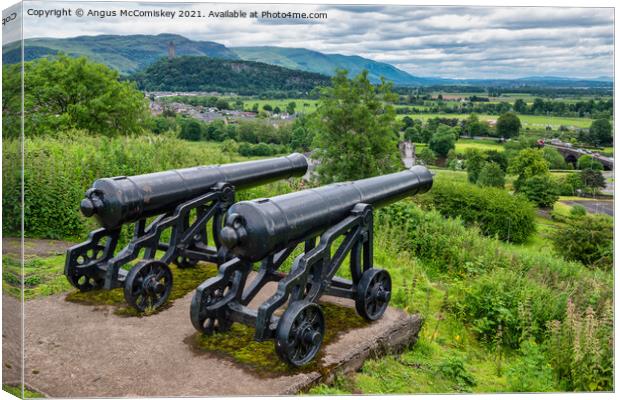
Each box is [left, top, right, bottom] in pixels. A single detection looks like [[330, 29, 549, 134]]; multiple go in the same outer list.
[[130, 56, 330, 94]]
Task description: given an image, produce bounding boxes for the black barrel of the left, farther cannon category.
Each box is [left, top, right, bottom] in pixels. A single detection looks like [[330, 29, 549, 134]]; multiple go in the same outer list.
[[80, 153, 308, 229]]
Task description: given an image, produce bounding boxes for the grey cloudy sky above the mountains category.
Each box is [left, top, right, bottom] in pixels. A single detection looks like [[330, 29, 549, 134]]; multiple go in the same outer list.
[[8, 1, 614, 78]]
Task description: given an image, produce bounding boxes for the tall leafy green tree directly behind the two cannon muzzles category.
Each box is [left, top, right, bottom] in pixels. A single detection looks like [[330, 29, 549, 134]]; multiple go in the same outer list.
[[311, 70, 400, 183]]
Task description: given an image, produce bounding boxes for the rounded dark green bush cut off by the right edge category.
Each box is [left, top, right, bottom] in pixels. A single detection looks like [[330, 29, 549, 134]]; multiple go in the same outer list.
[[551, 215, 613, 269]]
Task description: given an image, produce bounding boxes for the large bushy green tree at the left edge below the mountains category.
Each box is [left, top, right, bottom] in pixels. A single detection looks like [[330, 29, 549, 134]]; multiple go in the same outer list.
[[2, 55, 149, 137]]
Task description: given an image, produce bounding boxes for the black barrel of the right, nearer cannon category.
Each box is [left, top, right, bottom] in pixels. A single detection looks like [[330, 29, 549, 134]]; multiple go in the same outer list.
[[221, 165, 433, 261]]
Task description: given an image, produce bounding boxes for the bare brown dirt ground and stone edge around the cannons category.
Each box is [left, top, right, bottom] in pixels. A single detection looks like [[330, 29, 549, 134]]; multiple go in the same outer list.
[[2, 278, 421, 397]]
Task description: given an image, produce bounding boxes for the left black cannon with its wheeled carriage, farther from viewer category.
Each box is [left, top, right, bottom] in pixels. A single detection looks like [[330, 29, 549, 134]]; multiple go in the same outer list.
[[64, 153, 308, 311]]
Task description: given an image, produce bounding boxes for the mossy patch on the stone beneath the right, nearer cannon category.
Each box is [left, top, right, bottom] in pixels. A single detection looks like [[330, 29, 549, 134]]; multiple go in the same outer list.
[[194, 303, 368, 376]]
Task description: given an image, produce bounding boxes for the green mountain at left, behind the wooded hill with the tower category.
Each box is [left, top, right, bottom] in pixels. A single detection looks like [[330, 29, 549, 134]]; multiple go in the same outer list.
[[2, 33, 239, 74]]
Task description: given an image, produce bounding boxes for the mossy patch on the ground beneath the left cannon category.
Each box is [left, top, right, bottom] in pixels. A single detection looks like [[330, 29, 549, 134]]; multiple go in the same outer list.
[[65, 263, 217, 316]]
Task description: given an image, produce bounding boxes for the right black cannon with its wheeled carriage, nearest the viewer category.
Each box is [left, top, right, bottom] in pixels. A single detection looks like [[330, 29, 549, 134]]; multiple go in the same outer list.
[[190, 166, 433, 367]]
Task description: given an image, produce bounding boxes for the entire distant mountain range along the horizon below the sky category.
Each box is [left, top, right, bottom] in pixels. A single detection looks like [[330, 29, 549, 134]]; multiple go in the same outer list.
[[2, 33, 613, 88]]
